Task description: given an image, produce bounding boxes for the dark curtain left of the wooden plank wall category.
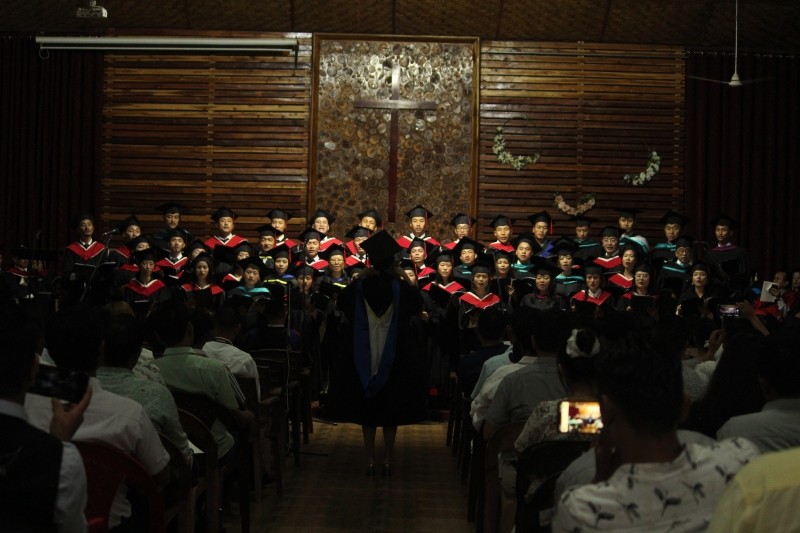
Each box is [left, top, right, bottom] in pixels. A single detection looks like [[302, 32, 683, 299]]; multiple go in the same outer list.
[[0, 37, 103, 264]]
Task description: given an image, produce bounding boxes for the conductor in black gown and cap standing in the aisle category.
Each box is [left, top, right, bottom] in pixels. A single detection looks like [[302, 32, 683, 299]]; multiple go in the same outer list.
[[329, 231, 427, 476]]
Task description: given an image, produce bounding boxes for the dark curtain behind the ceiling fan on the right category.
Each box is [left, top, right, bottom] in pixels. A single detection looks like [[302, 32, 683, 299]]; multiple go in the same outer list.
[[685, 51, 800, 279]]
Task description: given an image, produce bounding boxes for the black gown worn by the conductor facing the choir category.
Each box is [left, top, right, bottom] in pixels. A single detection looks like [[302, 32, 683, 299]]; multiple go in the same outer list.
[[328, 274, 428, 427]]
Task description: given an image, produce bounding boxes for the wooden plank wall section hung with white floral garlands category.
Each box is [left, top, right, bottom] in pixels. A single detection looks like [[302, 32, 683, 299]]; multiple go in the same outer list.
[[478, 41, 684, 242]]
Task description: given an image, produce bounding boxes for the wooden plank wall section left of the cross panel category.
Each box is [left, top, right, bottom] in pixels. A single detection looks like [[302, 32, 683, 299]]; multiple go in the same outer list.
[[102, 34, 311, 238]]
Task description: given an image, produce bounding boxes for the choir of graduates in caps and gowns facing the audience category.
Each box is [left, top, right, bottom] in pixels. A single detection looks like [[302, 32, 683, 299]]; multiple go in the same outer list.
[[4, 202, 780, 406]]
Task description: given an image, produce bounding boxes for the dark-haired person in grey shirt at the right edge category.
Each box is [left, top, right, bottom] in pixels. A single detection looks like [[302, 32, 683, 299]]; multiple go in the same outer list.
[[717, 330, 800, 452]]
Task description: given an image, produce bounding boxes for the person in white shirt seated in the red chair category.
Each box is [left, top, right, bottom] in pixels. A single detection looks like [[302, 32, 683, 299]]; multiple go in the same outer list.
[[25, 306, 169, 529]]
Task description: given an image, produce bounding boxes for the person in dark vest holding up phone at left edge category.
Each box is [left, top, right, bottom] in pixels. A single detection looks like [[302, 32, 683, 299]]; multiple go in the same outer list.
[[0, 308, 92, 533]]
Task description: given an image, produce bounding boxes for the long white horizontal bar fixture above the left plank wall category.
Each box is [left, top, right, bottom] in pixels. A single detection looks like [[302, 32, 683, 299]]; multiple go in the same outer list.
[[36, 37, 297, 53]]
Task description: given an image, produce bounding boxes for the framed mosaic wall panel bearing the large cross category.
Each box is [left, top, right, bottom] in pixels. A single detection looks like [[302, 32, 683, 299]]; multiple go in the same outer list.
[[312, 38, 476, 239]]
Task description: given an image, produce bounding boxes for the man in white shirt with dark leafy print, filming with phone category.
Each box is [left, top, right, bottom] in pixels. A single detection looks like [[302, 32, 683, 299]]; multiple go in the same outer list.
[[553, 338, 758, 531]]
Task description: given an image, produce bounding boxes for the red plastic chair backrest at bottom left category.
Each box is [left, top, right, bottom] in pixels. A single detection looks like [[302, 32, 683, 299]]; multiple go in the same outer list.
[[74, 441, 164, 533]]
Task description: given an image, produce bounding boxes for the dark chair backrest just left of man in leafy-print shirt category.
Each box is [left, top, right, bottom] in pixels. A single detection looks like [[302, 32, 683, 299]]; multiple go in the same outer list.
[[516, 440, 590, 531]]
